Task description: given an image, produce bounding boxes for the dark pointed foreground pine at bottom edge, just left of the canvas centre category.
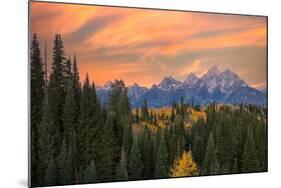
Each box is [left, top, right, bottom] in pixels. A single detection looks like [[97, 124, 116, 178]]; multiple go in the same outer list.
[[128, 138, 143, 180]]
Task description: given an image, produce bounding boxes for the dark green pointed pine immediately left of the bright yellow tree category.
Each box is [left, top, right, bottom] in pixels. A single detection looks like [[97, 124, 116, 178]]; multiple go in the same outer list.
[[155, 132, 169, 178]]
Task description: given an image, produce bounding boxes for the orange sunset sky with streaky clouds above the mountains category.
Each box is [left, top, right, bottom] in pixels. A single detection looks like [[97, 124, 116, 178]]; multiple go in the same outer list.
[[30, 2, 267, 89]]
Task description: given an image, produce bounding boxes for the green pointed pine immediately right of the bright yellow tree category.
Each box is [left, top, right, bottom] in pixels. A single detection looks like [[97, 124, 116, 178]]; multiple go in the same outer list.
[[202, 133, 218, 175]]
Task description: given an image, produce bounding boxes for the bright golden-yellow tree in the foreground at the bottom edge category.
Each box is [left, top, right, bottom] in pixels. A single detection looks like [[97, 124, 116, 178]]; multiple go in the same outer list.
[[170, 151, 198, 177]]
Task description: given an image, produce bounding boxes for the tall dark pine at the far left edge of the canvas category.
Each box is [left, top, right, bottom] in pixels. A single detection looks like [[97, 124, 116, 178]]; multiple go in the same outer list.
[[30, 34, 45, 185]]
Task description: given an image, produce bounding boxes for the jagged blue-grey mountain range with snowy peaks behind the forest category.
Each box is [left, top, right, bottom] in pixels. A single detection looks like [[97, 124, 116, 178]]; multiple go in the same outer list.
[[96, 65, 267, 107]]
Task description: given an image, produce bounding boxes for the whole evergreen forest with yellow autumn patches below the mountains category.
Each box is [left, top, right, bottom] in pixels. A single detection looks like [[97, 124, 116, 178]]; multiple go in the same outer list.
[[30, 34, 267, 186]]
